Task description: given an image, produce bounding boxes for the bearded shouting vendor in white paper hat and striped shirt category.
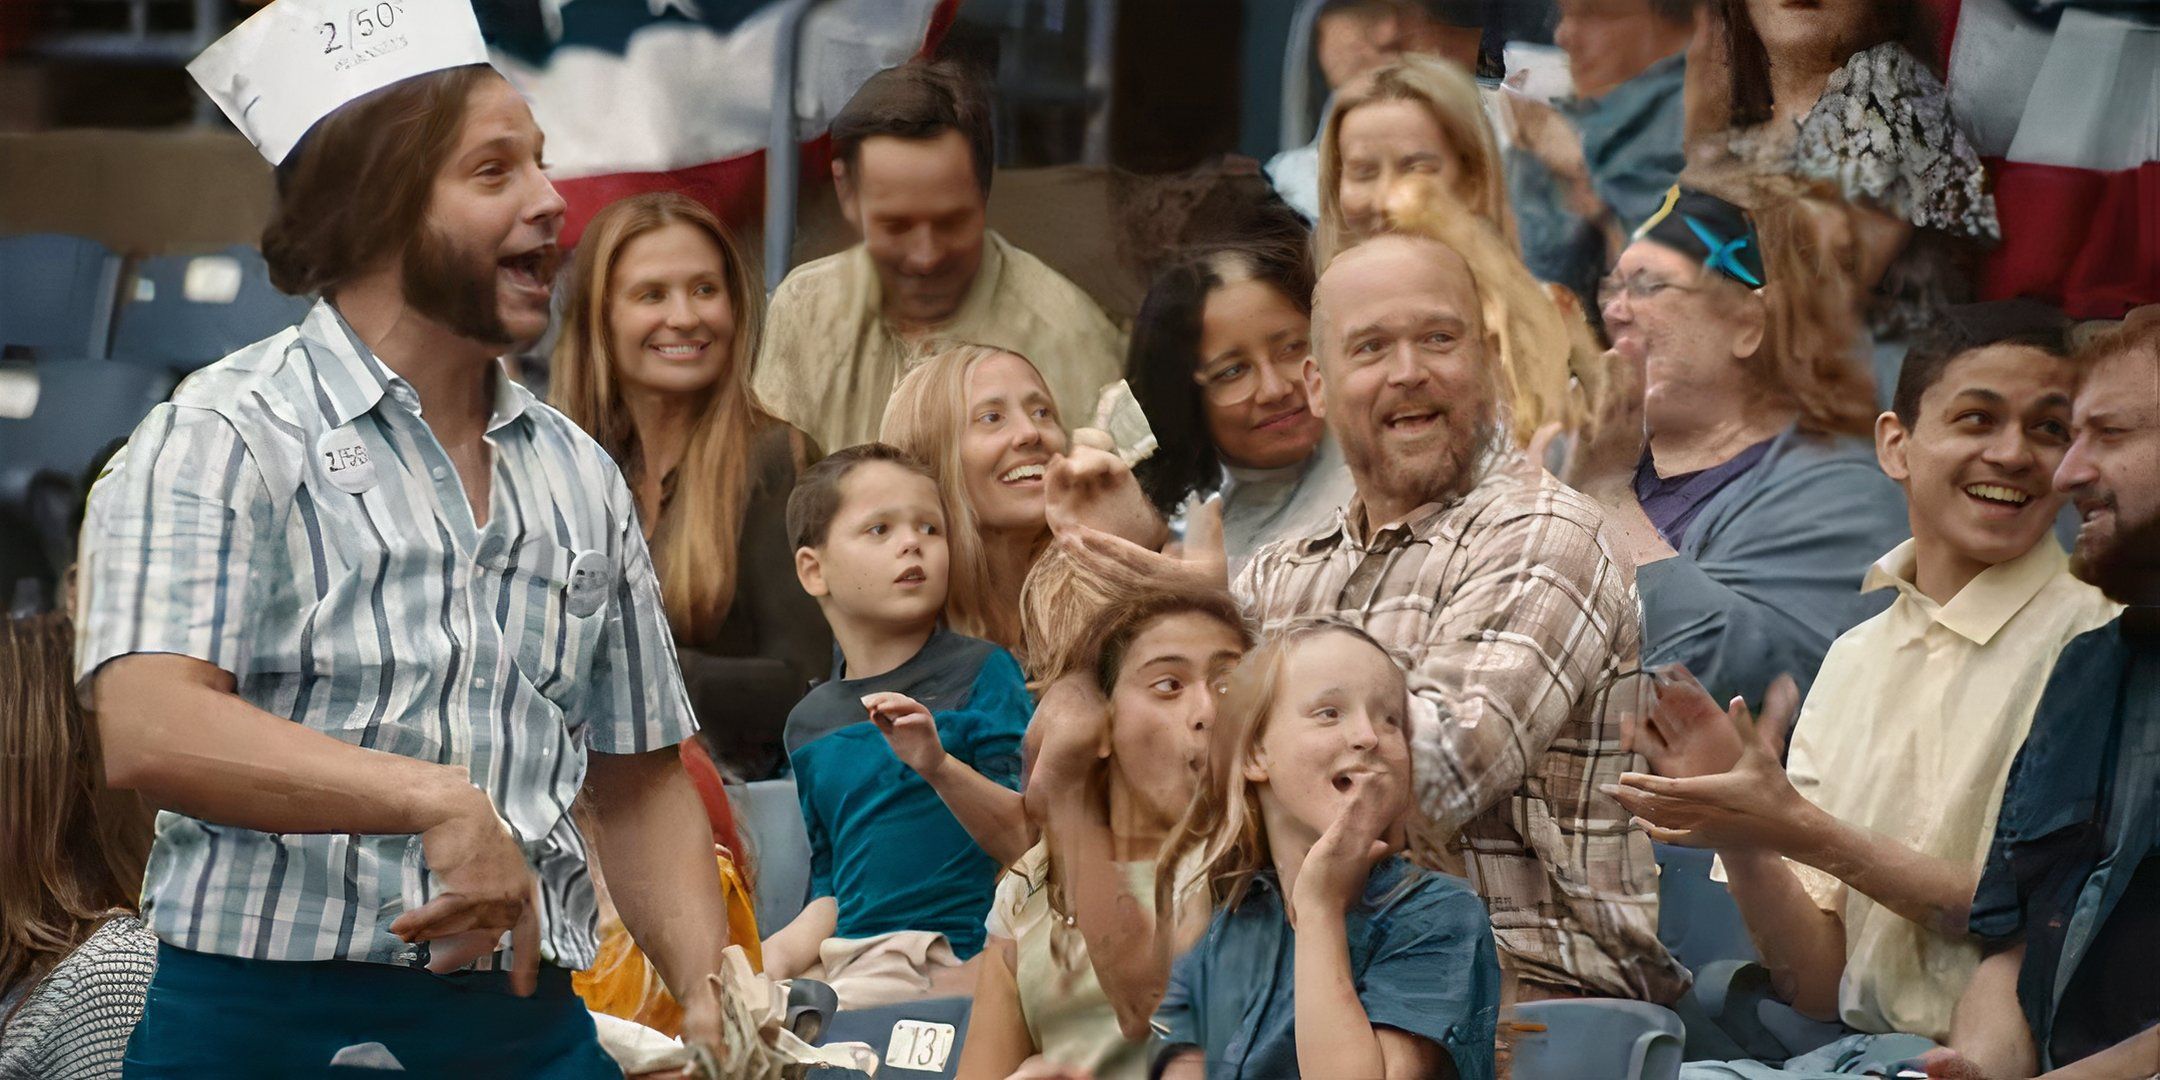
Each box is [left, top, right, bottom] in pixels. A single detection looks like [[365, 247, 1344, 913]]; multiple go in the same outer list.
[[78, 0, 728, 1078]]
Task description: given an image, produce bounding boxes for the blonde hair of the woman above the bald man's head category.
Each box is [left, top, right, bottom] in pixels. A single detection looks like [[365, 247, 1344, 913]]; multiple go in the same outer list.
[[1313, 56, 1521, 266]]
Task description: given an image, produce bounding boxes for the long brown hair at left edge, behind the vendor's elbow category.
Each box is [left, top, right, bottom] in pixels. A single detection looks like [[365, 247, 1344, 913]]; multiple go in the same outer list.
[[0, 616, 151, 1022]]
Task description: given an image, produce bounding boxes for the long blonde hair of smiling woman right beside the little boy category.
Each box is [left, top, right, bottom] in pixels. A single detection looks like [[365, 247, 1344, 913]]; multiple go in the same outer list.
[[879, 343, 1048, 648]]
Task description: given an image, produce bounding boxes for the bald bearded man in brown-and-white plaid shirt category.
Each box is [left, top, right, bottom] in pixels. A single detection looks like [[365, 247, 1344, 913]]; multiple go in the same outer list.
[[1236, 198, 1687, 1002]]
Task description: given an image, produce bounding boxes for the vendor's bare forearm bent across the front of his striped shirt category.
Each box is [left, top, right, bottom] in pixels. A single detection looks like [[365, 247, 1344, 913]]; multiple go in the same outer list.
[[97, 654, 473, 836]]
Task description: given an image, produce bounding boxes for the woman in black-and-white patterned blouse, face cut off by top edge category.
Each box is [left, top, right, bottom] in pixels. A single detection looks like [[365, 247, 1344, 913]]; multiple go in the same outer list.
[[1689, 0, 2002, 354]]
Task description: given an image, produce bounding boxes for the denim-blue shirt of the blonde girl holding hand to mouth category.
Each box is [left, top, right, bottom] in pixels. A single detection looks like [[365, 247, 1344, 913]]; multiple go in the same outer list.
[[1156, 855, 1499, 1080]]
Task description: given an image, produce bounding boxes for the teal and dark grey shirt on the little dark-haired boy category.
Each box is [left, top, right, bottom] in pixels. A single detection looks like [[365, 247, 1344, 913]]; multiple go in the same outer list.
[[786, 626, 1035, 959]]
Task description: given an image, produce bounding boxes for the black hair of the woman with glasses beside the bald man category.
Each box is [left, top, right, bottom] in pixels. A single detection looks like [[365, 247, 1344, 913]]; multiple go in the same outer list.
[[1125, 231, 1313, 514]]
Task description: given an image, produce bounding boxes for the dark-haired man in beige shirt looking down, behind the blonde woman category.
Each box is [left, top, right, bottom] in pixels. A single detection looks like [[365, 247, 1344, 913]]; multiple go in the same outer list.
[[752, 60, 1125, 451]]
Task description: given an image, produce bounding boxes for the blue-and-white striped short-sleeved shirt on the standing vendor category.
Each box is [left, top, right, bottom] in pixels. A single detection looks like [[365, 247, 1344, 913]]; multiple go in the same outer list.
[[76, 302, 696, 968]]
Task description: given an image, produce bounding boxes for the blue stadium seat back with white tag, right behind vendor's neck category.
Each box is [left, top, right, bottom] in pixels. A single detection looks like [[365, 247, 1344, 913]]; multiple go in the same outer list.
[[112, 246, 309, 372]]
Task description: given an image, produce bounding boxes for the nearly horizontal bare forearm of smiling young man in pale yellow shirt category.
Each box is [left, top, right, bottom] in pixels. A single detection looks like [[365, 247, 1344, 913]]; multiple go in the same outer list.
[[1784, 814, 1981, 937]]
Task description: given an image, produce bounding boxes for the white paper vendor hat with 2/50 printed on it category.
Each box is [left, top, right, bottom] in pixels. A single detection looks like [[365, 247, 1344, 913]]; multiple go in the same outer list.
[[188, 0, 488, 164]]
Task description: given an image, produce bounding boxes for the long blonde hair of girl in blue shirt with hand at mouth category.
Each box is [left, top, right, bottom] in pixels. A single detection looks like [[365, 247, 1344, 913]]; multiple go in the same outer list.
[[1156, 618, 1421, 927]]
